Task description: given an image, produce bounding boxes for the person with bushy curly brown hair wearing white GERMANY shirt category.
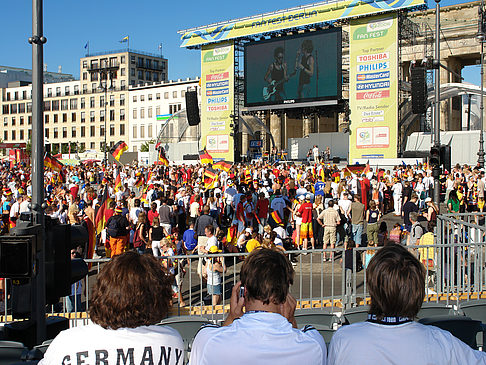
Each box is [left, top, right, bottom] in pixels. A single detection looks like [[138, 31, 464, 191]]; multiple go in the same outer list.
[[39, 251, 184, 365]]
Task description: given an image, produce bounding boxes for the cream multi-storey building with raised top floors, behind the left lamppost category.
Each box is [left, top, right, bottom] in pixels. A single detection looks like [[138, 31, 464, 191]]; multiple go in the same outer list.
[[0, 51, 168, 153]]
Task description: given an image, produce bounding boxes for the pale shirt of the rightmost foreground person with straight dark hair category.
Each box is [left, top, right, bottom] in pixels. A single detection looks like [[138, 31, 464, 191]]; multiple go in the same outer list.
[[328, 322, 486, 365]]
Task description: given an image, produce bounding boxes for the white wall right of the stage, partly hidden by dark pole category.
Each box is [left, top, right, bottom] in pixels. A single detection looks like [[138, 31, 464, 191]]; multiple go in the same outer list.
[[406, 131, 486, 166]]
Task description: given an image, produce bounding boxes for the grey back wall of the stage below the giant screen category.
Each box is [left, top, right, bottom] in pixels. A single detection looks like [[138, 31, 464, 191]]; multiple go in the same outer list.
[[288, 132, 349, 160]]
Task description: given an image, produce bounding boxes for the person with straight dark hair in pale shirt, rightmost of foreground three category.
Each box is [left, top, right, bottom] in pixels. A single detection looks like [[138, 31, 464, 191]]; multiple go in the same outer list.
[[328, 245, 486, 365]]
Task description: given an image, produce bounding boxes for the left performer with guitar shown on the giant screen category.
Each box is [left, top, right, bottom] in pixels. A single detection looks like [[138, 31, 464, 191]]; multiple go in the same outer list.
[[263, 47, 289, 101]]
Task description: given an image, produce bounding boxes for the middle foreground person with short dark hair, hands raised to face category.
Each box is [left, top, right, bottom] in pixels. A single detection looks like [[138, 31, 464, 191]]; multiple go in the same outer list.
[[189, 248, 327, 365]]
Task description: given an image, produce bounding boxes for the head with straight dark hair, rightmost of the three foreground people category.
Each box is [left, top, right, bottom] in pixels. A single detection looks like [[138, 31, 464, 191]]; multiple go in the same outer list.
[[366, 245, 425, 318]]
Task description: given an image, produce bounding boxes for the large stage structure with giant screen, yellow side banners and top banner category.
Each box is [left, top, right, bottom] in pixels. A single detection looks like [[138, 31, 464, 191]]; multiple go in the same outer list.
[[179, 0, 426, 161]]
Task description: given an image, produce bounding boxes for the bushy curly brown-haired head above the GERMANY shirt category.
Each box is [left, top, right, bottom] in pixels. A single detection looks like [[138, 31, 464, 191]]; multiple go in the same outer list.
[[90, 252, 172, 329]]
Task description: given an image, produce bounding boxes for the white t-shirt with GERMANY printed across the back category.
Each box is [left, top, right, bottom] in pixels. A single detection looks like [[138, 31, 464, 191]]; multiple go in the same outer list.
[[39, 324, 184, 365]]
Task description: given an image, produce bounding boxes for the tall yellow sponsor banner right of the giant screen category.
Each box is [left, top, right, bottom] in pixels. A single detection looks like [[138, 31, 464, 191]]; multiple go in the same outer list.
[[349, 14, 398, 162]]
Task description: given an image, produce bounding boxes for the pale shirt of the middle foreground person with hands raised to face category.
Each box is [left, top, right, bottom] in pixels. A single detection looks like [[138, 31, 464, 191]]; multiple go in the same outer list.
[[189, 312, 327, 365]]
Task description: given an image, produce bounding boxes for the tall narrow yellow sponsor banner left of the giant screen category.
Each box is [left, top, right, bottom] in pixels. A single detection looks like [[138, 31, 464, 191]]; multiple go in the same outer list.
[[201, 42, 235, 161]]
